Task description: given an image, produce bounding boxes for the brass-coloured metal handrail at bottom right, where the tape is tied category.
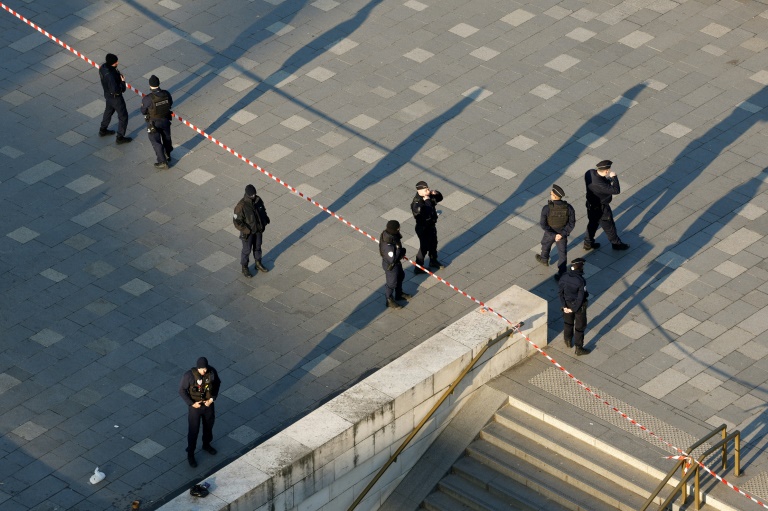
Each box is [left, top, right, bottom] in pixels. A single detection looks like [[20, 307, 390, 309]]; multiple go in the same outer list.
[[640, 424, 741, 511]]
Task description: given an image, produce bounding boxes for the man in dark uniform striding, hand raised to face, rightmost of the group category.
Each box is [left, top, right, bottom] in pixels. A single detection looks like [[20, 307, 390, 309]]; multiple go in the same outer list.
[[584, 160, 629, 250]]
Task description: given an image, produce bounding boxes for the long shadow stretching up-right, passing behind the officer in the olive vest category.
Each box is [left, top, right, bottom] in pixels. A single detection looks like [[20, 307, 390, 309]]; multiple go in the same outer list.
[[440, 83, 647, 259]]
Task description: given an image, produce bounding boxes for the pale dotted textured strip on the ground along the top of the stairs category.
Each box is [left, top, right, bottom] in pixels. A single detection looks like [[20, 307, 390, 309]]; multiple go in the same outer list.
[[530, 367, 709, 455]]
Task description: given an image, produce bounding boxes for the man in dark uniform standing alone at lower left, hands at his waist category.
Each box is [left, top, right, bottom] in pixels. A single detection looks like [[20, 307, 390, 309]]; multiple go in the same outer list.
[[179, 357, 221, 468]]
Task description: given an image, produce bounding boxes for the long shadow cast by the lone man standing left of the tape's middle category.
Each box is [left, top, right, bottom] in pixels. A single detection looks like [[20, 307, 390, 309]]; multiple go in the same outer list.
[[269, 94, 482, 266]]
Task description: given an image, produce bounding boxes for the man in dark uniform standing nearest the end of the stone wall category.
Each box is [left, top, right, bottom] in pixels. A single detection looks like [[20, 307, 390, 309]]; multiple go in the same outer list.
[[558, 258, 590, 355]]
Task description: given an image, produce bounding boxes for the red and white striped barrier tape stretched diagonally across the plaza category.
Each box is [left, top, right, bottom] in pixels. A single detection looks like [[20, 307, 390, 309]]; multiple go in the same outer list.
[[0, 3, 768, 509]]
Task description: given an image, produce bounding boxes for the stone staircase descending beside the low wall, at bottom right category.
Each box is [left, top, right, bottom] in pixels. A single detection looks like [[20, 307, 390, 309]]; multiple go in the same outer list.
[[421, 399, 731, 511]]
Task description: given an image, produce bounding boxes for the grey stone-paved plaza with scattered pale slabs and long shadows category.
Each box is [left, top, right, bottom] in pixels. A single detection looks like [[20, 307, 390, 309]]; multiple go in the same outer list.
[[0, 0, 768, 511]]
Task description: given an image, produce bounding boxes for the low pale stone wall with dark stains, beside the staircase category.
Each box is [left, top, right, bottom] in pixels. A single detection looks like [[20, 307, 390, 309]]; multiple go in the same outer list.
[[160, 286, 547, 511]]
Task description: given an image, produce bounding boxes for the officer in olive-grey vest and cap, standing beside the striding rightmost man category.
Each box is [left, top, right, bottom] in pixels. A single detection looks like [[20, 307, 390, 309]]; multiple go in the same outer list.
[[536, 185, 576, 280]]
